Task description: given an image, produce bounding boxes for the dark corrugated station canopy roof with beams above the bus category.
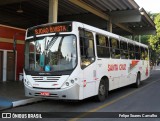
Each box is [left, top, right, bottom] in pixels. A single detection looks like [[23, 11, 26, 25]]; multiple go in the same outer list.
[[0, 0, 156, 35]]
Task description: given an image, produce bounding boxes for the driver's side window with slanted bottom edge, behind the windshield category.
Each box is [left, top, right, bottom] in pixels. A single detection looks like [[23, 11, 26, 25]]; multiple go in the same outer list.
[[79, 29, 95, 69]]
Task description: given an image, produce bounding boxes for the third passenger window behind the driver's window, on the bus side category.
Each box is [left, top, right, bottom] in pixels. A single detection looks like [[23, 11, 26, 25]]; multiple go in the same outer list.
[[120, 41, 128, 59]]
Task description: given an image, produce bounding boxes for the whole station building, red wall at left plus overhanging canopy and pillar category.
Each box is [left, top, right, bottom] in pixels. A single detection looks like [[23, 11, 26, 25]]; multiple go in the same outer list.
[[0, 0, 156, 81]]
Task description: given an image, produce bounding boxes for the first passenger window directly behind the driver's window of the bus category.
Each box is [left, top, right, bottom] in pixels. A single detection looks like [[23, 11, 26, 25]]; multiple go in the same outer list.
[[96, 34, 110, 58]]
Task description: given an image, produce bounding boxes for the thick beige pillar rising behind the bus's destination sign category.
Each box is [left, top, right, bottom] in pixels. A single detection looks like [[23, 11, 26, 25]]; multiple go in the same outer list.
[[48, 0, 58, 23]]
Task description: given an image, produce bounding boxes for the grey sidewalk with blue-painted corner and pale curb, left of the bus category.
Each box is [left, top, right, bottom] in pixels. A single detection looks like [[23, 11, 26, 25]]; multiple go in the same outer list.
[[0, 81, 42, 110]]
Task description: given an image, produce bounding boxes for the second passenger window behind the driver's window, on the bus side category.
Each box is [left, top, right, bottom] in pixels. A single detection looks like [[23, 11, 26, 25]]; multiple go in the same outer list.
[[110, 38, 120, 59]]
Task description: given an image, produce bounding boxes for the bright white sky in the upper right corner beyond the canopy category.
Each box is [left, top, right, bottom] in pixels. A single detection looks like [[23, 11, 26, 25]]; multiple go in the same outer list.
[[134, 0, 160, 13]]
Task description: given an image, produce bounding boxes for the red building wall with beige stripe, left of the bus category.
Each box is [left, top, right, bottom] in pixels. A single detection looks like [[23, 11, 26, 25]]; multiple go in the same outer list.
[[0, 25, 25, 81]]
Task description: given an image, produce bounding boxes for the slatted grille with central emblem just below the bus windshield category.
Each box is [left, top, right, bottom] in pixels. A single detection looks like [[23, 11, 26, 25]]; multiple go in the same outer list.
[[32, 76, 60, 82]]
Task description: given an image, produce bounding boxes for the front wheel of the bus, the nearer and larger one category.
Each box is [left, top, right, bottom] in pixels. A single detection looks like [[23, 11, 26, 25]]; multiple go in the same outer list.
[[96, 80, 108, 102]]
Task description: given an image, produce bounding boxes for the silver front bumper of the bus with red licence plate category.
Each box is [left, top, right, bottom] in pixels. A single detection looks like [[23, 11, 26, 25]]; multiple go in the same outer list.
[[24, 84, 80, 100]]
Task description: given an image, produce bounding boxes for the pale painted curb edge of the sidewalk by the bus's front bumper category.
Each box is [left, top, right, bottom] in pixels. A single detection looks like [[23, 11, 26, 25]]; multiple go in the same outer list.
[[12, 98, 44, 107]]
